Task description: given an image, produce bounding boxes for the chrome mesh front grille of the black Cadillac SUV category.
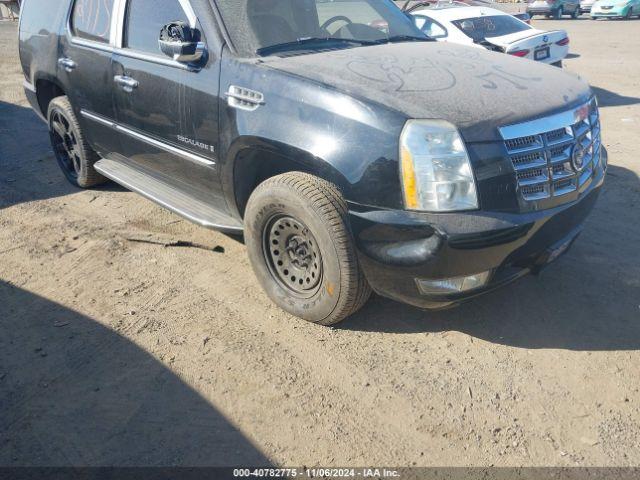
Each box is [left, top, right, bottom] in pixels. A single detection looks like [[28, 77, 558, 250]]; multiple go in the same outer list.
[[500, 99, 601, 201]]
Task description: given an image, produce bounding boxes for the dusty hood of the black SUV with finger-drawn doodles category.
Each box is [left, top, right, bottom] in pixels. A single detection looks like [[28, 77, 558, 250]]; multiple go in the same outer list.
[[261, 42, 591, 142]]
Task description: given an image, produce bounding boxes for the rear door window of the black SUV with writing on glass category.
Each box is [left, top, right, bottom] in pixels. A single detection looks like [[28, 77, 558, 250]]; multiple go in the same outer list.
[[71, 0, 115, 43]]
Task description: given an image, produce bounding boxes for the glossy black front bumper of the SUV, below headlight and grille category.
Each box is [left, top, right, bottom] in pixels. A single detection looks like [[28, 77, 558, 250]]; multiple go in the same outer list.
[[349, 148, 607, 309]]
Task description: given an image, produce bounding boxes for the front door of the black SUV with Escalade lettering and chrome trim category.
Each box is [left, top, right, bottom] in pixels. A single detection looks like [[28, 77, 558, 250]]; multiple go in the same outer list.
[[113, 0, 223, 207]]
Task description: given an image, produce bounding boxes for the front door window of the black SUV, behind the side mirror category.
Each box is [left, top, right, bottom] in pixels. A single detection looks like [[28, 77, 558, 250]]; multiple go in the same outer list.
[[124, 0, 189, 55]]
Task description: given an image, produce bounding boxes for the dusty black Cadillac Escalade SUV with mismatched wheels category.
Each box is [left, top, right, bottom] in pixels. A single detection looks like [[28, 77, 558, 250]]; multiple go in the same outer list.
[[20, 0, 607, 325]]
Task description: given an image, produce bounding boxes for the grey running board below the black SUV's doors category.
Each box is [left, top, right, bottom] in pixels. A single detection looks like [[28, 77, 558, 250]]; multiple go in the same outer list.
[[94, 158, 243, 234]]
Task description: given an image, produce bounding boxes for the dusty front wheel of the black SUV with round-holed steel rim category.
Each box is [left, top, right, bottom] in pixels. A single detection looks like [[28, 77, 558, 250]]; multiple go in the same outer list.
[[245, 172, 371, 325]]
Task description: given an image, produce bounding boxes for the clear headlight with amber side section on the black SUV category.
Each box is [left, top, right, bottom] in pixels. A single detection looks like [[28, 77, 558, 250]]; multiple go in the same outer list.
[[400, 120, 478, 212]]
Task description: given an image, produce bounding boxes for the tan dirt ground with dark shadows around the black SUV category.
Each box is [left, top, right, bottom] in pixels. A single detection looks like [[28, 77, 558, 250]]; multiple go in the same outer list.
[[0, 19, 640, 466]]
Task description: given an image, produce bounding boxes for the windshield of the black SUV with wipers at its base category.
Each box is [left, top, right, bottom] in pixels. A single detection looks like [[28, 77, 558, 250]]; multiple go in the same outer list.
[[216, 0, 427, 56]]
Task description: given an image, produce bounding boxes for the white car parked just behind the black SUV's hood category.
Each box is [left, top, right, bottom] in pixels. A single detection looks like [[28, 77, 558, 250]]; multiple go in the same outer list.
[[410, 3, 569, 67]]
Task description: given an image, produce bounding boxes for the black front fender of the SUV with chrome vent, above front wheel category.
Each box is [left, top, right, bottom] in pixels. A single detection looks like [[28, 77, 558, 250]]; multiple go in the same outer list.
[[220, 53, 406, 215]]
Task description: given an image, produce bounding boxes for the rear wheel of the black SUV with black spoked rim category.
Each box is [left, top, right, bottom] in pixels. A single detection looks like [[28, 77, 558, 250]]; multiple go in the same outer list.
[[47, 97, 107, 188]]
